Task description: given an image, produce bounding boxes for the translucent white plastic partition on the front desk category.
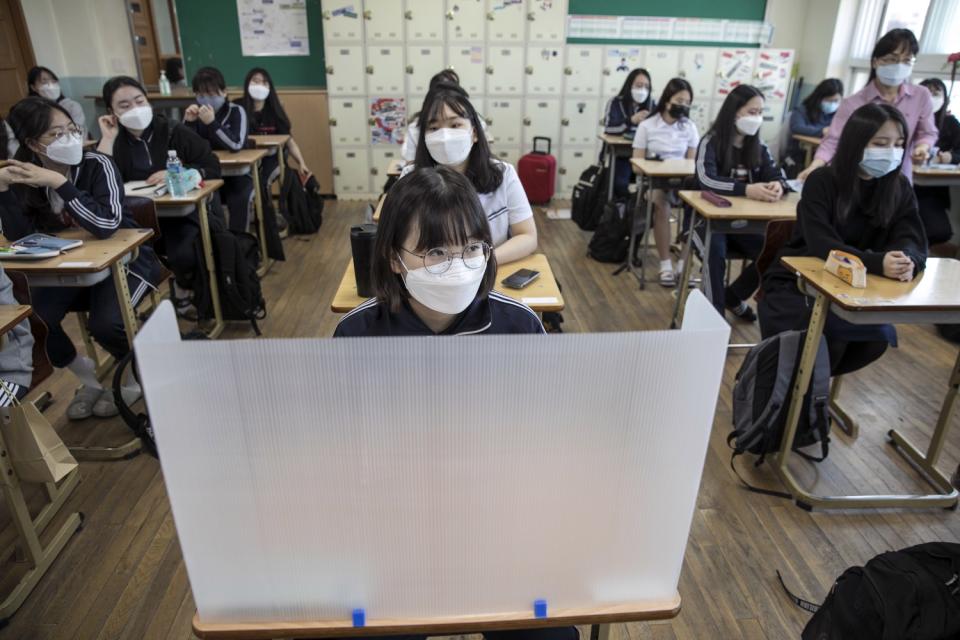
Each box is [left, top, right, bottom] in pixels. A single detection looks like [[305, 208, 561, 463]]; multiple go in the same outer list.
[[136, 292, 730, 623]]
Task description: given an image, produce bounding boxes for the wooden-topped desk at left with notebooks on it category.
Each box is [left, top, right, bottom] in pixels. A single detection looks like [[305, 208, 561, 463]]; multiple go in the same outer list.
[[3, 229, 153, 460]]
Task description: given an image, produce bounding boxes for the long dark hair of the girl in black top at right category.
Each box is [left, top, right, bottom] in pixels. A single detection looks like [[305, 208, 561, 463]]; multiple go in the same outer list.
[[830, 102, 910, 227]]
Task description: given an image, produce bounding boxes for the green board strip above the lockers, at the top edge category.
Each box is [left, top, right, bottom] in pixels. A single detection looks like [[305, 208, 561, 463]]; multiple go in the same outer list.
[[567, 0, 764, 20]]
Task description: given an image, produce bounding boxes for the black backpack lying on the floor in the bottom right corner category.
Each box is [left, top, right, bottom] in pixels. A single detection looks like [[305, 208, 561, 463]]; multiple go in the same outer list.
[[777, 542, 960, 640]]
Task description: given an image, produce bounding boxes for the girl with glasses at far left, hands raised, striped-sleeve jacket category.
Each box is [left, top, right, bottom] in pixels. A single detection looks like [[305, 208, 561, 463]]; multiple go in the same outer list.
[[0, 97, 160, 420]]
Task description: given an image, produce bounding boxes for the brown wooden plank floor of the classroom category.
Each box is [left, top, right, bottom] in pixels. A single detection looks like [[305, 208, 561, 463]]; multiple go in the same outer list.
[[0, 196, 960, 640]]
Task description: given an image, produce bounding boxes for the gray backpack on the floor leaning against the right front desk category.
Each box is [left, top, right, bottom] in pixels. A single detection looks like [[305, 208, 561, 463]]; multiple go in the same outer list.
[[727, 331, 830, 498]]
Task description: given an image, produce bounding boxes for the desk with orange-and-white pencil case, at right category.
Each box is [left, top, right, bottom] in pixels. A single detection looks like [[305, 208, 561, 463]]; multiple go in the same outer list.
[[771, 257, 960, 509]]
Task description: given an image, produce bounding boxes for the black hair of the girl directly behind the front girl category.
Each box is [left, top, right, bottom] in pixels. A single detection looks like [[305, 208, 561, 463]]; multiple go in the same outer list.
[[414, 84, 503, 193]]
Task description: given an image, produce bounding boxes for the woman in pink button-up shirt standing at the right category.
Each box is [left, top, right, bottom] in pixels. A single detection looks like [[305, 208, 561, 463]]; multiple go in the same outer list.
[[797, 29, 937, 182]]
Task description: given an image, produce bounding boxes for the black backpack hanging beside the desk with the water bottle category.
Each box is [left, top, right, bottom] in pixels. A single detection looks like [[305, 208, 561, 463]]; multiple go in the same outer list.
[[193, 216, 267, 336]]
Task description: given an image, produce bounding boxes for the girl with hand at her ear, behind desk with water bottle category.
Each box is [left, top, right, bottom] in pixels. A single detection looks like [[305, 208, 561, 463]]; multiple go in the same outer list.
[[97, 76, 220, 315]]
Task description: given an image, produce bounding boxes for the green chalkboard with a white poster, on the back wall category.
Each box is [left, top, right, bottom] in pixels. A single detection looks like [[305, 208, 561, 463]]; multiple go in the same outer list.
[[176, 0, 327, 88]]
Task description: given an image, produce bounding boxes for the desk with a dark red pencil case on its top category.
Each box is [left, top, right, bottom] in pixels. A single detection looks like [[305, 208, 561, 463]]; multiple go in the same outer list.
[[670, 191, 800, 329]]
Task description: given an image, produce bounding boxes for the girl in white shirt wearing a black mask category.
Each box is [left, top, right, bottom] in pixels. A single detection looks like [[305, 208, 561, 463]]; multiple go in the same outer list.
[[633, 78, 700, 287]]
